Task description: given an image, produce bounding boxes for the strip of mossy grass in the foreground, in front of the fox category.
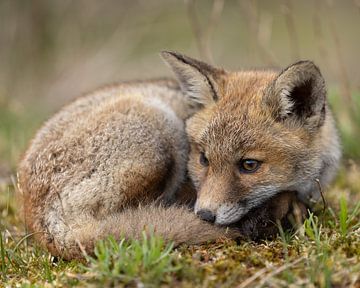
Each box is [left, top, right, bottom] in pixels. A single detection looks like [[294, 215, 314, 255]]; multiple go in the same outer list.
[[0, 198, 360, 287]]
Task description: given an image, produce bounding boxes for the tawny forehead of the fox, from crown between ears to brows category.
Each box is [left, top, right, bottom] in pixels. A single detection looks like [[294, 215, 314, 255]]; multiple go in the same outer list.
[[187, 71, 306, 157]]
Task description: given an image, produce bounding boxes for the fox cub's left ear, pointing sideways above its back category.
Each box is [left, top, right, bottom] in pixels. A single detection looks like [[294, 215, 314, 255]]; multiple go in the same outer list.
[[161, 51, 225, 106]]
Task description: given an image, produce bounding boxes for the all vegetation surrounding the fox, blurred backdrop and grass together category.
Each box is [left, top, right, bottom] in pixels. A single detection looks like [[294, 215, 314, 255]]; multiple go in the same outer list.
[[0, 0, 360, 287]]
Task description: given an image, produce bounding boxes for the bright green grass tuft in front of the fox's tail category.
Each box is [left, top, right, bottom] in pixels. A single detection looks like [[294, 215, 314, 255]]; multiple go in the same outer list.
[[84, 233, 180, 286]]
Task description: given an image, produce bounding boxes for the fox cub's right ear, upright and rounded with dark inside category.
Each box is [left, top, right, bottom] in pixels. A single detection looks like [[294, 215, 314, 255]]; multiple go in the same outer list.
[[267, 61, 326, 128]]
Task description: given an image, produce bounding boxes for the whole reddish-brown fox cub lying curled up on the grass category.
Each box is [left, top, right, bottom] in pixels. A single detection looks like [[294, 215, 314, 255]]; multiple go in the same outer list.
[[18, 52, 340, 259]]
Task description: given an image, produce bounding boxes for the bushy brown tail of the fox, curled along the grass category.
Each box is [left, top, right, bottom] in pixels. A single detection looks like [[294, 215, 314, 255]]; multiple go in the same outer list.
[[46, 204, 239, 259]]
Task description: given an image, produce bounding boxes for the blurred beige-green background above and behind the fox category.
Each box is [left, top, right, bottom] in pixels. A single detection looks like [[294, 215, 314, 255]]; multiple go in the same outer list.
[[0, 0, 360, 179]]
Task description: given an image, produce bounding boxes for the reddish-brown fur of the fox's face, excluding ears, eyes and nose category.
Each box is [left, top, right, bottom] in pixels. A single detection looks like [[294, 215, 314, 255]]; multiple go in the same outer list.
[[180, 60, 340, 224]]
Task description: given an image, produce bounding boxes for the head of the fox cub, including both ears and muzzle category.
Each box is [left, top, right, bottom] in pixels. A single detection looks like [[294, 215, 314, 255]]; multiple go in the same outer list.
[[162, 52, 339, 225]]
